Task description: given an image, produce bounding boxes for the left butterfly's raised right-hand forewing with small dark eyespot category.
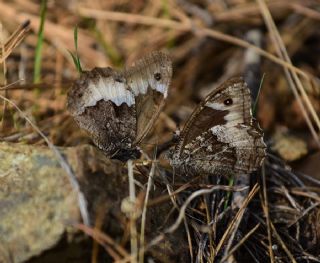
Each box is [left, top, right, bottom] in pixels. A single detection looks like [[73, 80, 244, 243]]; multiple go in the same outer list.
[[125, 52, 172, 143]]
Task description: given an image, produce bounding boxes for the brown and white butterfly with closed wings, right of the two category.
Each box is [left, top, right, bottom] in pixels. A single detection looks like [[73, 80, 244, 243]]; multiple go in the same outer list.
[[169, 78, 266, 175]]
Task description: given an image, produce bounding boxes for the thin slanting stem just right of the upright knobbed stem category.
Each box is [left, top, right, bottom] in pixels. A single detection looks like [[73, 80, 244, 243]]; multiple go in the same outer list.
[[139, 161, 155, 263]]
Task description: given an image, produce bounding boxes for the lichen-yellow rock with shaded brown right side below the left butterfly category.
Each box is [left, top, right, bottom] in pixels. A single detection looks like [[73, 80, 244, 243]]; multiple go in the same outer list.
[[0, 143, 188, 263]]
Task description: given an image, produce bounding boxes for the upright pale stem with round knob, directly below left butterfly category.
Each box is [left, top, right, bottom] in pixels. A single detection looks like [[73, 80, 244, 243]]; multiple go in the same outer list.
[[127, 160, 138, 263]]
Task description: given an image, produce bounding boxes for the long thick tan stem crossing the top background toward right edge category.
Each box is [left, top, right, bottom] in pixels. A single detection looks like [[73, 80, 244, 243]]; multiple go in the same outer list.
[[78, 7, 312, 81]]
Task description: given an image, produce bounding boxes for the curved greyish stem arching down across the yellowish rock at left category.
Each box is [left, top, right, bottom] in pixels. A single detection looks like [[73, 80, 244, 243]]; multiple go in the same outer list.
[[0, 95, 90, 226]]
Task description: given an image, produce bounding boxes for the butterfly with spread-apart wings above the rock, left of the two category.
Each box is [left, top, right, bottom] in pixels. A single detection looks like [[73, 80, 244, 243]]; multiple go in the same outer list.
[[67, 52, 172, 160]]
